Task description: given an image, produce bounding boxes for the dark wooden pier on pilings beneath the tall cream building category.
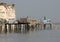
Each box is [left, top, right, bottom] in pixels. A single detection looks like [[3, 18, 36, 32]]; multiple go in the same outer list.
[[0, 22, 30, 32]]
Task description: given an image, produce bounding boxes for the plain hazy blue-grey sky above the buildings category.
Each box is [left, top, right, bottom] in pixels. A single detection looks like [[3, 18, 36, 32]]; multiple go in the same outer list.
[[0, 0, 60, 22]]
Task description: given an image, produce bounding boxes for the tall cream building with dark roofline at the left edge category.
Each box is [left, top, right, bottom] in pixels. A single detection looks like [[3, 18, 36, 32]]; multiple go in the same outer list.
[[0, 3, 16, 21]]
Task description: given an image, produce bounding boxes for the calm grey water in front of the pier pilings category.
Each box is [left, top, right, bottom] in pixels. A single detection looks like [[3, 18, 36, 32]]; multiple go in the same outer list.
[[0, 25, 60, 42]]
